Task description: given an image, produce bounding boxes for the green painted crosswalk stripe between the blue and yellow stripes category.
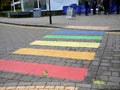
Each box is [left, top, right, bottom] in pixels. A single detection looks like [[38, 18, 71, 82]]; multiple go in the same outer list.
[[43, 35, 102, 40]]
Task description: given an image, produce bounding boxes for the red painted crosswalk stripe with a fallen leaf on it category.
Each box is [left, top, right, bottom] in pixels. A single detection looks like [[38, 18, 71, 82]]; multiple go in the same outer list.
[[0, 59, 88, 80]]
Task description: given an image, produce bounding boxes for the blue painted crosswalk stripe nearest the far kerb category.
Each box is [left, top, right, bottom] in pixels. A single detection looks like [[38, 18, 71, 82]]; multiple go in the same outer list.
[[52, 30, 105, 35]]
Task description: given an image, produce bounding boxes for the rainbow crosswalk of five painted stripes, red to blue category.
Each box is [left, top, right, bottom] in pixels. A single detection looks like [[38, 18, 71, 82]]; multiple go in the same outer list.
[[0, 30, 105, 81]]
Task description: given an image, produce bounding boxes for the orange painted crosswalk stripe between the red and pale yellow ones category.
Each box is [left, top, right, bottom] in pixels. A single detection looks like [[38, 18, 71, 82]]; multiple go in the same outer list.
[[13, 48, 95, 60]]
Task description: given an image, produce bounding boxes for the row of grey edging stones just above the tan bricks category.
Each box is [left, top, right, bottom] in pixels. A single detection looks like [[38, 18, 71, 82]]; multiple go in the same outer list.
[[0, 82, 120, 90]]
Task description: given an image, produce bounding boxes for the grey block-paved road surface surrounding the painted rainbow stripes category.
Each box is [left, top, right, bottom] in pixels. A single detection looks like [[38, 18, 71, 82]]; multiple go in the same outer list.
[[0, 25, 120, 90]]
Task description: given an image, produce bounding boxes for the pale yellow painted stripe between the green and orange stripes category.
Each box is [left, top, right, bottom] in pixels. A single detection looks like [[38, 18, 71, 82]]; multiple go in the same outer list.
[[31, 40, 100, 48]]
